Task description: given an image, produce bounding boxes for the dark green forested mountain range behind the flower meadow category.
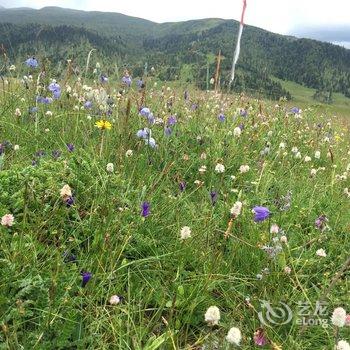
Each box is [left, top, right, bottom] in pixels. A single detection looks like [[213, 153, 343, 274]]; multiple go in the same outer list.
[[0, 7, 350, 98]]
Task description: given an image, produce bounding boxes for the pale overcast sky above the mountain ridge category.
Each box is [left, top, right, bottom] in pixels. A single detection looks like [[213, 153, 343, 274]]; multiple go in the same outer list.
[[0, 0, 350, 47]]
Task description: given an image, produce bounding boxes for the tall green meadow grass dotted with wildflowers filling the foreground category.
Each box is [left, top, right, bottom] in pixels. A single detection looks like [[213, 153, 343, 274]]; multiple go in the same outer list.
[[0, 72, 350, 350]]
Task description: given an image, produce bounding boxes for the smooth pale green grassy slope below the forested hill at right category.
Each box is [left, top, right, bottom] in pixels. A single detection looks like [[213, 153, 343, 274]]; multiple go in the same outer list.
[[274, 78, 350, 118]]
